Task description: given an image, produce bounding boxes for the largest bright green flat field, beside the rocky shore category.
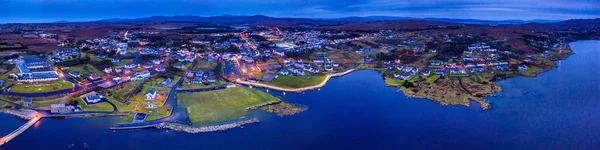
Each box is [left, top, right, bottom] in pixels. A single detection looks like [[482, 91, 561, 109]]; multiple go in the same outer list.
[[177, 87, 279, 124]]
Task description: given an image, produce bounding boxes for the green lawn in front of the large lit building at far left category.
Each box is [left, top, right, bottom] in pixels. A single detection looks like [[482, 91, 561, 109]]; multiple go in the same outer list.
[[10, 80, 73, 93]]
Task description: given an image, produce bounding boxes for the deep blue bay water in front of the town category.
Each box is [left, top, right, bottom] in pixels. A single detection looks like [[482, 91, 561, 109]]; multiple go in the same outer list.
[[0, 41, 600, 149]]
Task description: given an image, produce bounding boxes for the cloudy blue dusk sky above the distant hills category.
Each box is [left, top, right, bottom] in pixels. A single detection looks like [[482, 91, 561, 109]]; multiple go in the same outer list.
[[0, 0, 600, 23]]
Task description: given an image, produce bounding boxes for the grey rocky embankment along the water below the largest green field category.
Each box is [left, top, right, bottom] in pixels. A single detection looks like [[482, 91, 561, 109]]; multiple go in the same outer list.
[[156, 118, 259, 133]]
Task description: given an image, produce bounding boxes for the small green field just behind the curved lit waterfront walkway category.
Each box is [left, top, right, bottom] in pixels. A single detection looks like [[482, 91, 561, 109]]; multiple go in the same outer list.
[[269, 76, 325, 88]]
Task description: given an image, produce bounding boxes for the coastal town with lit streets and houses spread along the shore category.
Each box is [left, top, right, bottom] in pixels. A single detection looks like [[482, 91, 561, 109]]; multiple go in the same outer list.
[[0, 16, 598, 145]]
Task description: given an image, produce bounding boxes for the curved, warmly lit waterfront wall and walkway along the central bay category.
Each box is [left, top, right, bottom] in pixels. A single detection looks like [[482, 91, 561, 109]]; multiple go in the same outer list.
[[235, 69, 355, 92]]
